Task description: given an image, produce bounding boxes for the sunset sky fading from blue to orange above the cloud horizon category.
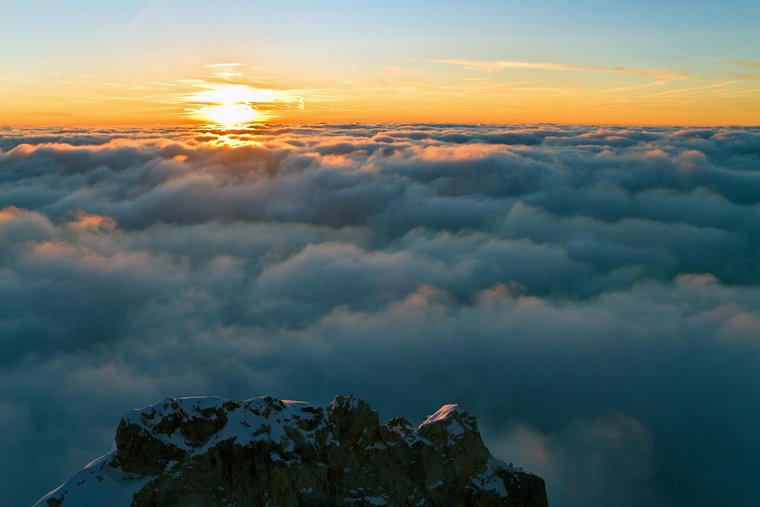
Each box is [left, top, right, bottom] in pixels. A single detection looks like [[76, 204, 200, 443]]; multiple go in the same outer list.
[[0, 0, 760, 125]]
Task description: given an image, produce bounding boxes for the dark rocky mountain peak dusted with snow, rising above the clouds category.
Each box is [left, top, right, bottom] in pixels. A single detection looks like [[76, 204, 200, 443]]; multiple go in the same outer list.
[[37, 396, 547, 507]]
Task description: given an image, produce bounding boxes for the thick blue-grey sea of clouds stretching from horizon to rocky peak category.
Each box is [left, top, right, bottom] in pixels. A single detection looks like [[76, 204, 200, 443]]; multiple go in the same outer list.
[[0, 125, 760, 506]]
